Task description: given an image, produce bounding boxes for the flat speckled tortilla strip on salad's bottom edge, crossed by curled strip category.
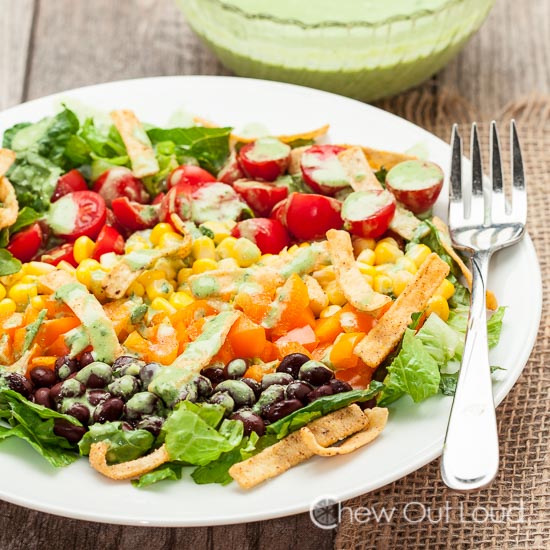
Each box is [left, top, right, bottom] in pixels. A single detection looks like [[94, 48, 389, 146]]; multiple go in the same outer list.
[[229, 405, 368, 489]]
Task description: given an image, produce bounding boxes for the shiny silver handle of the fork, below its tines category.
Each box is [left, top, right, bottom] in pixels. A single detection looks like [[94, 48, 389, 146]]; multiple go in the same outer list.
[[441, 251, 499, 491]]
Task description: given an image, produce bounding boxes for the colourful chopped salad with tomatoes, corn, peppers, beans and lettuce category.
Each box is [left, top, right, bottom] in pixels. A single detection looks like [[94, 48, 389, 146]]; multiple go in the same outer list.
[[0, 107, 504, 488]]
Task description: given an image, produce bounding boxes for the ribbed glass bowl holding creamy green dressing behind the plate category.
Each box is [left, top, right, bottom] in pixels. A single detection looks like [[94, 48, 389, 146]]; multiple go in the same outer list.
[[176, 0, 494, 101]]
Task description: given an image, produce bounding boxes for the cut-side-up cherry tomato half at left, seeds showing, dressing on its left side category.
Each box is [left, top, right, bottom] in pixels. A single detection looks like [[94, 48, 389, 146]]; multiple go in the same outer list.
[[48, 191, 107, 240]]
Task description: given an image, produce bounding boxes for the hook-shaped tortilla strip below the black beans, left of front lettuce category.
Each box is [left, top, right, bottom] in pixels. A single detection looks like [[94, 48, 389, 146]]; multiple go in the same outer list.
[[89, 441, 170, 480]]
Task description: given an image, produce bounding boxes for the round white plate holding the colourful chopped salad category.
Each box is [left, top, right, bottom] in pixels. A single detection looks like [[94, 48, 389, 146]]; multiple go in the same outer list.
[[0, 76, 542, 526]]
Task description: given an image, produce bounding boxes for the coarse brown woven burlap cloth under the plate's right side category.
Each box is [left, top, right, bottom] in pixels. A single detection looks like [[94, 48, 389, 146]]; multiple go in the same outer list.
[[336, 85, 550, 550]]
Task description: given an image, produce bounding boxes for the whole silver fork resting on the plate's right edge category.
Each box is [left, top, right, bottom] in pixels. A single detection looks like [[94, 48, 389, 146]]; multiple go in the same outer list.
[[441, 121, 527, 491]]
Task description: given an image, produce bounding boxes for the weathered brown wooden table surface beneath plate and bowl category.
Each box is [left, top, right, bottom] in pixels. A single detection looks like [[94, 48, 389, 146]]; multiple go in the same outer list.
[[0, 0, 550, 550]]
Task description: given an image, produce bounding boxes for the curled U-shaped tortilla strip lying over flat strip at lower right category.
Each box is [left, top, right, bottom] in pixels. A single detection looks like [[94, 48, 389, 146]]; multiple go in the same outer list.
[[300, 407, 388, 456]]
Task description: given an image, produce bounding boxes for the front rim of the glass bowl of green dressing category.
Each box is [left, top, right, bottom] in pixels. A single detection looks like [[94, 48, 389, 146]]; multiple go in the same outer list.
[[190, 0, 488, 29]]
